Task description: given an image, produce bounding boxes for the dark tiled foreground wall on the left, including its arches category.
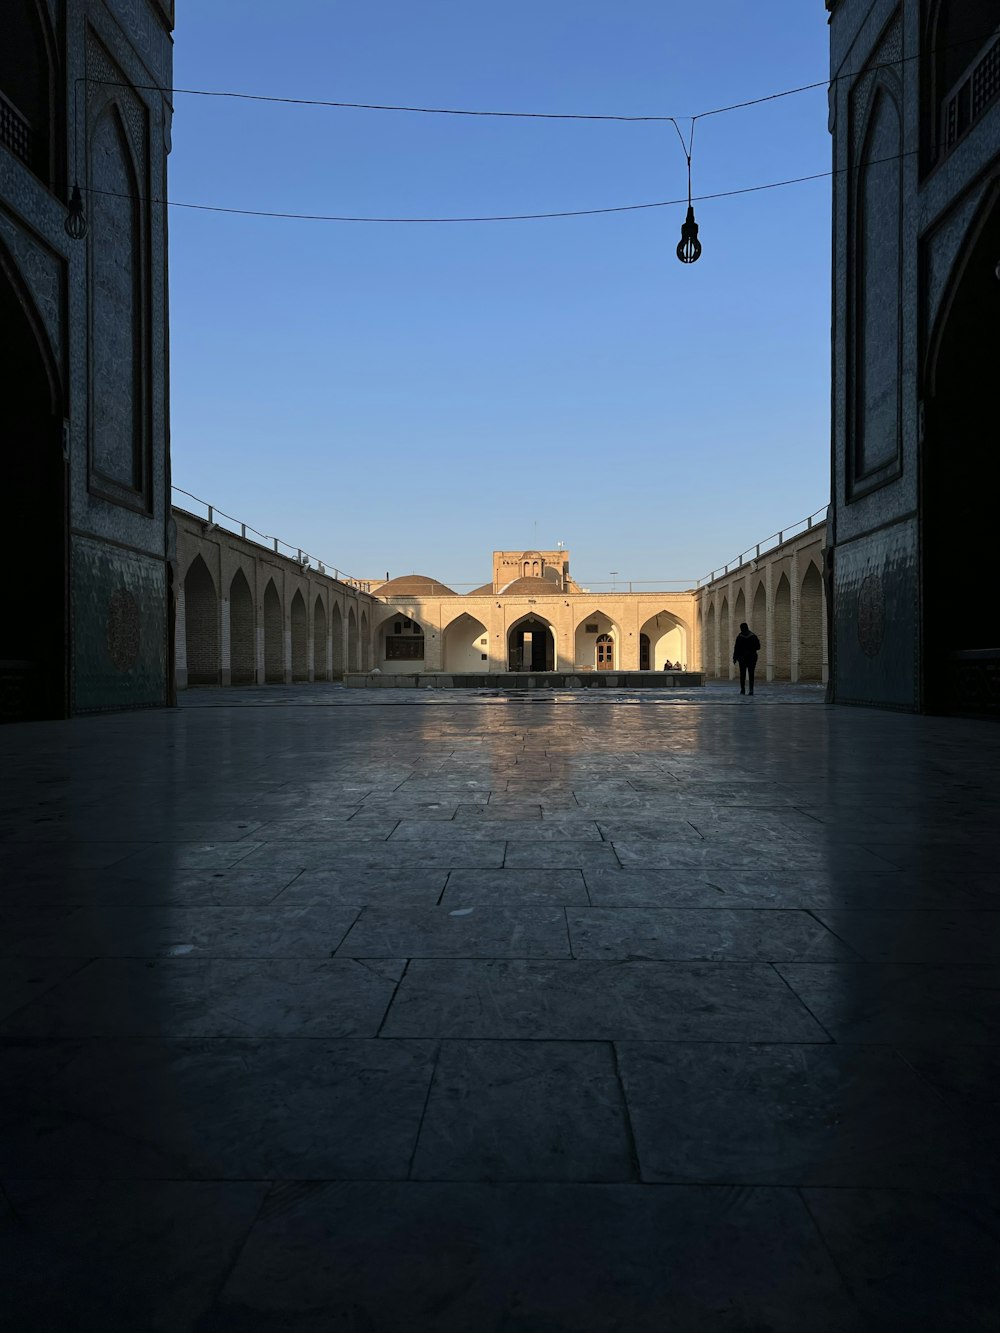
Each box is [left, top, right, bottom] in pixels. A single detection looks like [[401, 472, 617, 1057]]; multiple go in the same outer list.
[[0, 0, 173, 718]]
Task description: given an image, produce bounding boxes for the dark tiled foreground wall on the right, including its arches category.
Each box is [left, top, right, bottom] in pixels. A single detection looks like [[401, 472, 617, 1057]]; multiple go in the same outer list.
[[827, 0, 1000, 712]]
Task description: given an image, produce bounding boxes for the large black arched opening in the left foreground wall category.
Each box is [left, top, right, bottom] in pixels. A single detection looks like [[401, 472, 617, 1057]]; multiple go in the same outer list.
[[0, 247, 68, 721]]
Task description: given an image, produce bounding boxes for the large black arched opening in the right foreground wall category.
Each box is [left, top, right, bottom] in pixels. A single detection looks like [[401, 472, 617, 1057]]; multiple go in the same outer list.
[[920, 190, 1000, 712]]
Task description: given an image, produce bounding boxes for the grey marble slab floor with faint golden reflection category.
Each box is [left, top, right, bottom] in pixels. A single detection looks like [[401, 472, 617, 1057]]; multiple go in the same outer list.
[[0, 685, 1000, 1333]]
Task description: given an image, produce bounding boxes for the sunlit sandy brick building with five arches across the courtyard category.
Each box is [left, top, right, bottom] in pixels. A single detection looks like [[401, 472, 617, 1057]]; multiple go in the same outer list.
[[371, 548, 699, 674]]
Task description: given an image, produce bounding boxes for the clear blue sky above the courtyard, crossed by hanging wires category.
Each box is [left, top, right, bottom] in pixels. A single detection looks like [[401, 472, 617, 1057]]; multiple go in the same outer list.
[[169, 0, 831, 591]]
